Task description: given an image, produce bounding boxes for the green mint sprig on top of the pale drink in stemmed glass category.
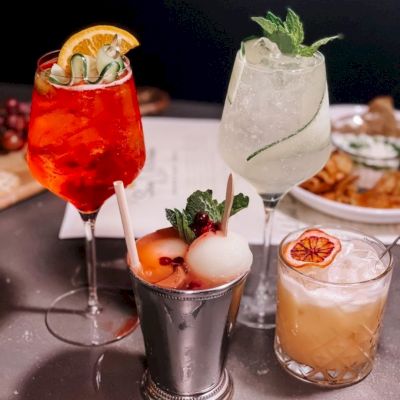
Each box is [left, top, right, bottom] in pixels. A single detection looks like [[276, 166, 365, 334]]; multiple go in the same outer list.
[[251, 8, 342, 57]]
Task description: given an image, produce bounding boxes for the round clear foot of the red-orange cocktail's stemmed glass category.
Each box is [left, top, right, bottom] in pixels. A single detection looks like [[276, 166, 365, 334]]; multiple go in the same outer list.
[[46, 287, 139, 346]]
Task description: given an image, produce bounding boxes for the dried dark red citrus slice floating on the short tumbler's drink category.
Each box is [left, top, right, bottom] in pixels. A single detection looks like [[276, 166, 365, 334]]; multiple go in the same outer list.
[[282, 229, 342, 268]]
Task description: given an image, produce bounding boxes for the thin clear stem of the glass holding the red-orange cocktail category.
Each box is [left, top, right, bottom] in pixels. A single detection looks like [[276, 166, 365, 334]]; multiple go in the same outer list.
[[80, 211, 101, 315]]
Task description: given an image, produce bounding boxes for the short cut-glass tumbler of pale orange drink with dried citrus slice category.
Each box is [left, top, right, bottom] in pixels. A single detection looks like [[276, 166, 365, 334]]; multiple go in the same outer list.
[[275, 228, 392, 386]]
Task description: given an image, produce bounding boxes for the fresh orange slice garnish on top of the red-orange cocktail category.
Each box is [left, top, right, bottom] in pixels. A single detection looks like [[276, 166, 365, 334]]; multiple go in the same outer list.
[[57, 25, 139, 70]]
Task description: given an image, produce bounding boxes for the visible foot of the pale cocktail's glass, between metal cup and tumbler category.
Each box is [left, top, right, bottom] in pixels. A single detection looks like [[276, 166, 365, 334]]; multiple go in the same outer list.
[[237, 294, 276, 329]]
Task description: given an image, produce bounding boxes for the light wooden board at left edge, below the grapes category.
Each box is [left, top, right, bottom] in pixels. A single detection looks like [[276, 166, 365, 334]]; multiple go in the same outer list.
[[0, 149, 44, 210]]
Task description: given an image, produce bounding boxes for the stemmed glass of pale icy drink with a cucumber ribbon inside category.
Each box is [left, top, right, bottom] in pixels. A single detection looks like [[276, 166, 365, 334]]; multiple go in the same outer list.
[[219, 38, 331, 328]]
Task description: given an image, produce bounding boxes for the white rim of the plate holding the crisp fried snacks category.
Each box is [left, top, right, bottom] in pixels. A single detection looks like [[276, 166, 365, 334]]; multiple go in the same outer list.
[[290, 104, 400, 224]]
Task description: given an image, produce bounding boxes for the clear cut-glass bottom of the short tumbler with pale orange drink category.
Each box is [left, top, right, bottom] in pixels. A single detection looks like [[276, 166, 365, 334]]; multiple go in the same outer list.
[[274, 337, 372, 388]]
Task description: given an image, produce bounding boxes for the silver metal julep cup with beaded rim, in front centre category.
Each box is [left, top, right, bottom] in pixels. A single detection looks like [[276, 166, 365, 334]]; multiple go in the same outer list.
[[131, 273, 247, 400]]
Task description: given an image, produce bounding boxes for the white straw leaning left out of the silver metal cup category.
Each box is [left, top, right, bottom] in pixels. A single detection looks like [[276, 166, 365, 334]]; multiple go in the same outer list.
[[114, 181, 140, 269]]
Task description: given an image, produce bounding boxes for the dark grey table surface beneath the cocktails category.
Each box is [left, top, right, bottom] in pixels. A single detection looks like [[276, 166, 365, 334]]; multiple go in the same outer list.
[[0, 85, 400, 400]]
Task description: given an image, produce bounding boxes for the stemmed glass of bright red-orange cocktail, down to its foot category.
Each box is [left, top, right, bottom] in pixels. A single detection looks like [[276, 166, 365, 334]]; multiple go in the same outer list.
[[27, 27, 145, 346]]
